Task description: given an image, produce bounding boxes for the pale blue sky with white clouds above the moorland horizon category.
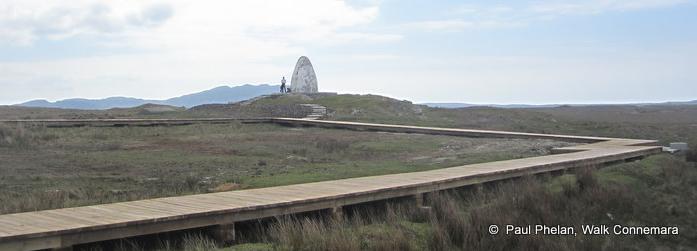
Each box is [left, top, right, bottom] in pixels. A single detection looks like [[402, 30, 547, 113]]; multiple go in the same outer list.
[[0, 0, 697, 104]]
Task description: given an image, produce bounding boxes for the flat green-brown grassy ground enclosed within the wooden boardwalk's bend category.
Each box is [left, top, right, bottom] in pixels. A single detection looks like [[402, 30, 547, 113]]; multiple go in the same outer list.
[[0, 123, 569, 213]]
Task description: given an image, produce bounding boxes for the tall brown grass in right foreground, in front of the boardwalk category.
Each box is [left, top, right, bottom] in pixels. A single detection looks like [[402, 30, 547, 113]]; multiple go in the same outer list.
[[235, 156, 697, 250]]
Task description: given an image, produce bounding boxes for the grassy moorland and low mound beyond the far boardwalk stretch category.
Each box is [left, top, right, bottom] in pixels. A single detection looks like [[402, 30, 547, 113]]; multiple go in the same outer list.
[[6, 94, 697, 145]]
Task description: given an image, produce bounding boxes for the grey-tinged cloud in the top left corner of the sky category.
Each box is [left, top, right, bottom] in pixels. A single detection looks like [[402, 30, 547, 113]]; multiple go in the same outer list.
[[0, 0, 173, 46]]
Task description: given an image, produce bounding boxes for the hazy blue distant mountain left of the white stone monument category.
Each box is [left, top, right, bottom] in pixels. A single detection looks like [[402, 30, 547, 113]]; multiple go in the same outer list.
[[17, 85, 279, 110]]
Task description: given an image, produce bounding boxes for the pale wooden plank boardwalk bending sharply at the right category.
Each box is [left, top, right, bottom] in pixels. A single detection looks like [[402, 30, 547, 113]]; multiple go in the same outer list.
[[0, 118, 660, 250]]
